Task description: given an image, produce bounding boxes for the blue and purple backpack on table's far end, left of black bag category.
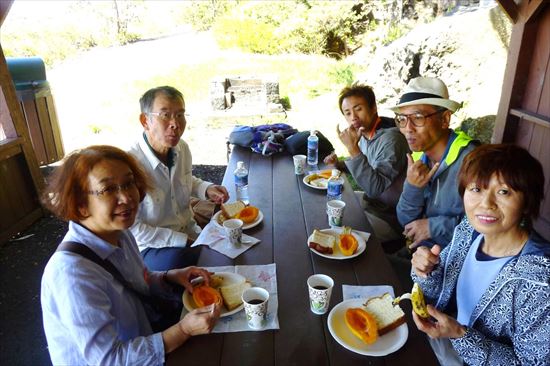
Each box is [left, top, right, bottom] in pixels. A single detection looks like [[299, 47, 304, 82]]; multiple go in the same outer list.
[[229, 123, 297, 156]]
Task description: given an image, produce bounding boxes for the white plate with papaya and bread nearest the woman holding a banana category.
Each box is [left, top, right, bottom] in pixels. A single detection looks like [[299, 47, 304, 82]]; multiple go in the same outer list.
[[327, 299, 409, 356]]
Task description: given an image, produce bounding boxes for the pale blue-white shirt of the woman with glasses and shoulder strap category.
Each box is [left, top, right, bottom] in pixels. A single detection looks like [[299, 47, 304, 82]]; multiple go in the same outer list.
[[41, 221, 165, 365]]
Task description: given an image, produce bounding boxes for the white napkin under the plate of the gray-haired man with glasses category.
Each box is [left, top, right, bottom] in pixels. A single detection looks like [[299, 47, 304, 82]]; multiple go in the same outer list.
[[191, 221, 260, 259]]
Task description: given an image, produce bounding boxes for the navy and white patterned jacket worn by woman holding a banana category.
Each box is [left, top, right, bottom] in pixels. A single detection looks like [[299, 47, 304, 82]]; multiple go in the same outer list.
[[411, 217, 550, 366]]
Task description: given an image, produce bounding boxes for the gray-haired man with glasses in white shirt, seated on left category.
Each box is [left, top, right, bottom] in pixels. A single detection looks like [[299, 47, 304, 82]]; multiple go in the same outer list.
[[129, 86, 229, 271]]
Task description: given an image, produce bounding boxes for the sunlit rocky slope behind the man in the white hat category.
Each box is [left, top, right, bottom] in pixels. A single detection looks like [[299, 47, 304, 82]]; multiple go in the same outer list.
[[358, 7, 507, 135]]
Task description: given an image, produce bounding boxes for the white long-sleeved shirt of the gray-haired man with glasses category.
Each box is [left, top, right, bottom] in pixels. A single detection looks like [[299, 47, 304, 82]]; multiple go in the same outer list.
[[128, 135, 212, 251]]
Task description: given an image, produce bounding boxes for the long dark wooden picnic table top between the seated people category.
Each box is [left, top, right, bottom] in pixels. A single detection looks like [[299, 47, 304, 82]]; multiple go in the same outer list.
[[166, 147, 438, 366]]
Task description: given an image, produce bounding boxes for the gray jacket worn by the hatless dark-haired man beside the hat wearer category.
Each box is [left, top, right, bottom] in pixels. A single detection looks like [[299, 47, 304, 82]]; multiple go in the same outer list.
[[345, 117, 409, 226]]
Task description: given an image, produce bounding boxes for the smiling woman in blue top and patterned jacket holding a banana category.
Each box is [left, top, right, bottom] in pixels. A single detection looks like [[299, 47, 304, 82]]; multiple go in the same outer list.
[[412, 144, 550, 365]]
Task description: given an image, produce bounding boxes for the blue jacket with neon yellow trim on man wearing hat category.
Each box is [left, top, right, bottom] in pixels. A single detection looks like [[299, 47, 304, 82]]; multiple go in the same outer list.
[[397, 131, 478, 248]]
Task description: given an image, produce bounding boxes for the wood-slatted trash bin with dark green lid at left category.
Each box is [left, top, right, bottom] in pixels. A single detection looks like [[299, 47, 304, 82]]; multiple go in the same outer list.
[[6, 57, 65, 165]]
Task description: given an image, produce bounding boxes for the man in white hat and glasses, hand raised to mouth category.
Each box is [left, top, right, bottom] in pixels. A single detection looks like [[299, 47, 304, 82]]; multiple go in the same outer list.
[[391, 77, 477, 248]]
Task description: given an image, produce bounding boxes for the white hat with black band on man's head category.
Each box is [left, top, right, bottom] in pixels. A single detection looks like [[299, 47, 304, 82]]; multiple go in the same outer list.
[[390, 77, 461, 112]]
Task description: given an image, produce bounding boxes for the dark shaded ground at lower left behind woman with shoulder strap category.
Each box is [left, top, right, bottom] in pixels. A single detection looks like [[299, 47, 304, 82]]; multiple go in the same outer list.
[[0, 216, 67, 365]]
